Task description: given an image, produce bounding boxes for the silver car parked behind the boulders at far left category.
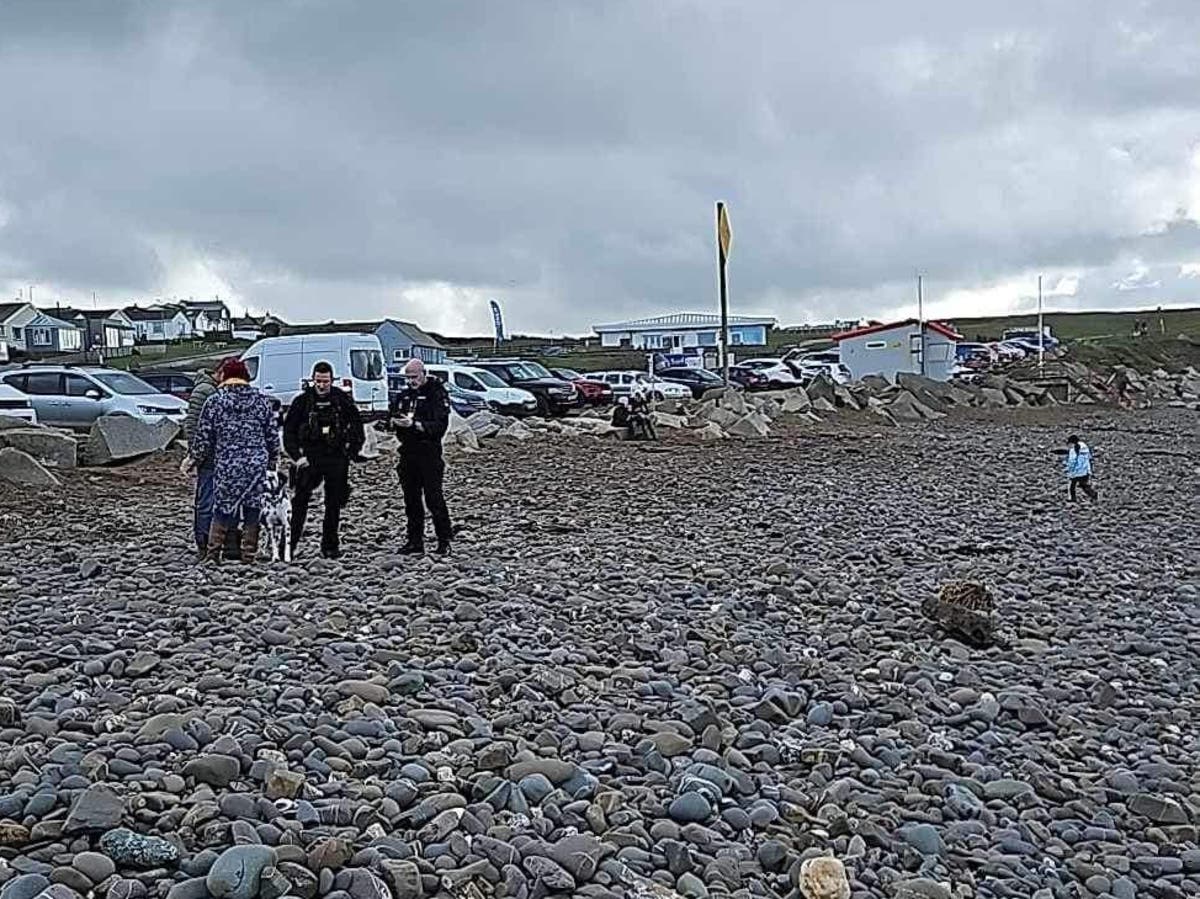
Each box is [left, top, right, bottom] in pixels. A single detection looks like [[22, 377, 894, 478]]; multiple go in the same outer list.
[[0, 365, 187, 428]]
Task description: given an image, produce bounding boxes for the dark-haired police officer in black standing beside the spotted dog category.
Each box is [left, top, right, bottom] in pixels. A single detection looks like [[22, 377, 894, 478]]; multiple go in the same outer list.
[[283, 362, 366, 559]]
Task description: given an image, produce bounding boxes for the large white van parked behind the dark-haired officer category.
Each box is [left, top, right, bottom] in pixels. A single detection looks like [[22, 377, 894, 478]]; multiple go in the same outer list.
[[241, 334, 388, 415]]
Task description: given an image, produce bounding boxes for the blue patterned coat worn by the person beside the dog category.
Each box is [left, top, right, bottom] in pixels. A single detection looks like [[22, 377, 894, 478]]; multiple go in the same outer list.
[[188, 382, 280, 516]]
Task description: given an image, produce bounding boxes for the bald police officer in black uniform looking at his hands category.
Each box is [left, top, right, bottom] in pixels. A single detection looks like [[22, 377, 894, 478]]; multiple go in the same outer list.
[[391, 359, 451, 556]]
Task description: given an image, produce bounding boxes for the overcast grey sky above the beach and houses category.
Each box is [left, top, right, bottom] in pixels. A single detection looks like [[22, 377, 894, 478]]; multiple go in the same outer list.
[[0, 0, 1200, 332]]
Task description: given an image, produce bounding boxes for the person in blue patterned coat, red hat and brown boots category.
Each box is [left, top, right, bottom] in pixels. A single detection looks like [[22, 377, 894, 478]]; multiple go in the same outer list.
[[188, 360, 280, 564]]
